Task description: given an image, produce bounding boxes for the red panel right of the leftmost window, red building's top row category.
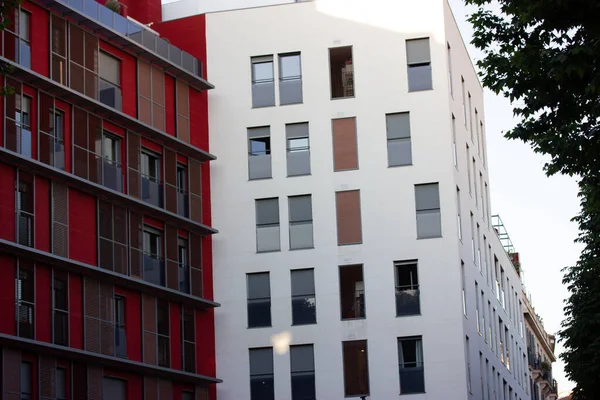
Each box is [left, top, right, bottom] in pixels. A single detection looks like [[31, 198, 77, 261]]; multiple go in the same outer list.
[[21, 1, 50, 77]]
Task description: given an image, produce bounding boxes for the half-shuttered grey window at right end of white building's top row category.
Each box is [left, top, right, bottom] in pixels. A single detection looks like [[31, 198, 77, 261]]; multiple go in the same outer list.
[[406, 38, 433, 92]]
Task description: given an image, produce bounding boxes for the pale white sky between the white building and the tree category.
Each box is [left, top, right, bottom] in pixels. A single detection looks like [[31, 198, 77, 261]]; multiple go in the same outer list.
[[449, 0, 582, 392]]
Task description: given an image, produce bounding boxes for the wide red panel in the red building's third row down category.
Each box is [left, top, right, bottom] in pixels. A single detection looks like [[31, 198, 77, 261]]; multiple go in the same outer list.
[[69, 189, 98, 265]]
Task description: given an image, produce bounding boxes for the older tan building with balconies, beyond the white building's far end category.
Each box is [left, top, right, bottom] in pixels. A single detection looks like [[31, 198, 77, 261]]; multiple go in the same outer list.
[[522, 291, 558, 400]]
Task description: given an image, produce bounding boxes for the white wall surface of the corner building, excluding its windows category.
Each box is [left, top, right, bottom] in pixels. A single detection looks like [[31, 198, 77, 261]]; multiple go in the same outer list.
[[207, 0, 528, 400]]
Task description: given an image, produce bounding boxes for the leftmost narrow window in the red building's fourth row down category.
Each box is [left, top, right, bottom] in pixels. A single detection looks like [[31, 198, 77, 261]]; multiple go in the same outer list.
[[16, 259, 35, 339]]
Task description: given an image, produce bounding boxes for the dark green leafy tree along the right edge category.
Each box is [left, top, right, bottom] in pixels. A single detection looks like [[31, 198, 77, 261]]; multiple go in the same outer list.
[[465, 0, 600, 400]]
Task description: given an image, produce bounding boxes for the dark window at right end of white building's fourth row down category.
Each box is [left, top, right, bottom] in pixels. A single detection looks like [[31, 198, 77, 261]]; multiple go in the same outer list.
[[394, 261, 421, 317]]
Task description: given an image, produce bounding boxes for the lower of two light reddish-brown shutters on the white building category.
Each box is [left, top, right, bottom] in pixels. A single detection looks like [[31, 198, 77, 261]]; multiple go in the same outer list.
[[335, 190, 362, 245]]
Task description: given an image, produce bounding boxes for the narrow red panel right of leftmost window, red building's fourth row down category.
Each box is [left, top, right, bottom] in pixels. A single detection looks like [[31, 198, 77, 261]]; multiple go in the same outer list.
[[35, 264, 52, 342]]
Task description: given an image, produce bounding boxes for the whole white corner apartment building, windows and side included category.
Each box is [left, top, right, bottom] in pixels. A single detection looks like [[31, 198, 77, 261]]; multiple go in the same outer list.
[[164, 0, 530, 400]]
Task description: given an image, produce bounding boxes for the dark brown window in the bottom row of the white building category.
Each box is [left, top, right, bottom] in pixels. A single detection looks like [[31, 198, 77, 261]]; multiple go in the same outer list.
[[342, 340, 369, 397]]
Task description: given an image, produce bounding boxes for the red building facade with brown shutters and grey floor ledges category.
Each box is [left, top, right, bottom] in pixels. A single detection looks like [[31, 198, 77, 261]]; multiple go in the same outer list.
[[0, 0, 219, 400]]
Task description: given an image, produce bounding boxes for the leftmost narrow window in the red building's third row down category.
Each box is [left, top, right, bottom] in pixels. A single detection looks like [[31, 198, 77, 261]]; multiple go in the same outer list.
[[17, 170, 34, 247]]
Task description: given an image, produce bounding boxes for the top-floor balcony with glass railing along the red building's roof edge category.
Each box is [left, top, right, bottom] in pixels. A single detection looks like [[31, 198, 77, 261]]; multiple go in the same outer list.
[[35, 0, 213, 90]]
